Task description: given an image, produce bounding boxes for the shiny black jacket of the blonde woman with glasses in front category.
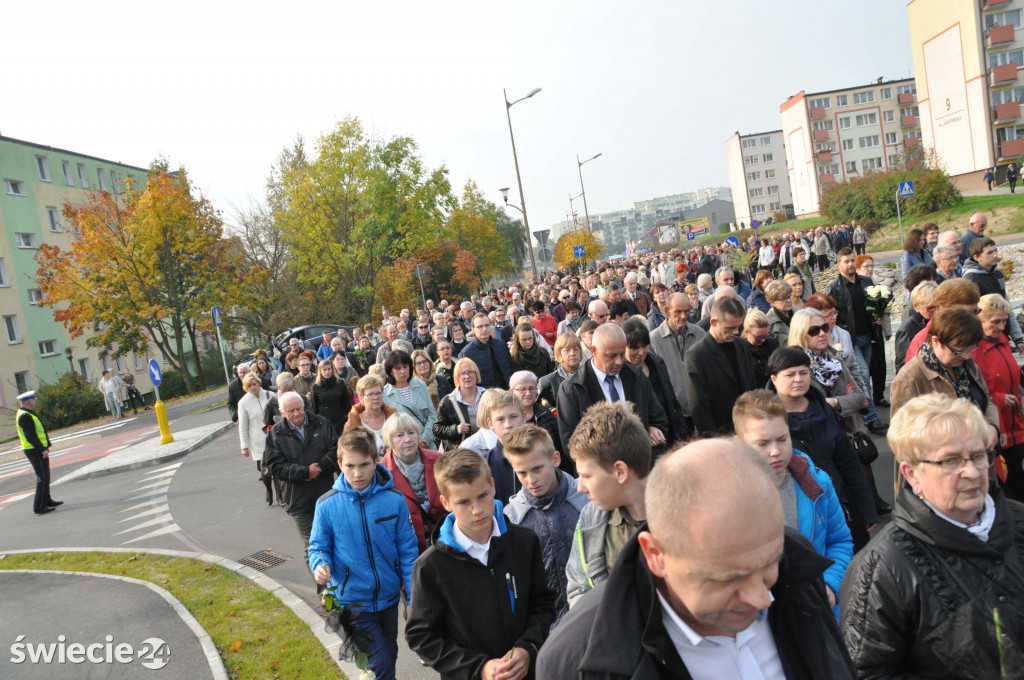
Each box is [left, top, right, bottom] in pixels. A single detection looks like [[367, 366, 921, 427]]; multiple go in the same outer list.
[[840, 485, 1024, 680]]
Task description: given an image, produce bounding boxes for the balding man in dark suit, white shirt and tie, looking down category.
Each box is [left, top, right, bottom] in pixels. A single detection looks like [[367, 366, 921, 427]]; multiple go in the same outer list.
[[558, 324, 669, 449]]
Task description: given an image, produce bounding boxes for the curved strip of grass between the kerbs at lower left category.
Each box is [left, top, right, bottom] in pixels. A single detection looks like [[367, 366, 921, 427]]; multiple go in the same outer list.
[[0, 552, 343, 679]]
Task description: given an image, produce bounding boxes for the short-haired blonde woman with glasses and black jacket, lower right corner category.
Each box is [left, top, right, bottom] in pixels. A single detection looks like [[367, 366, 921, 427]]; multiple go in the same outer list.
[[840, 393, 1024, 679]]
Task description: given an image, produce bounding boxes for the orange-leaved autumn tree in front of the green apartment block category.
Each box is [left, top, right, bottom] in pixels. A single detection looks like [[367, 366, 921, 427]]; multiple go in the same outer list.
[[36, 162, 263, 391]]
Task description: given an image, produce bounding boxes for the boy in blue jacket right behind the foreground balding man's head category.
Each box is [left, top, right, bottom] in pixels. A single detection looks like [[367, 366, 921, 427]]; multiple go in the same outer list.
[[732, 389, 853, 619]]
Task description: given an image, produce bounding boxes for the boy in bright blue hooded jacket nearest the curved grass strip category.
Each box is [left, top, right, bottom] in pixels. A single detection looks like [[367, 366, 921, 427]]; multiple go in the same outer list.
[[308, 427, 419, 680]]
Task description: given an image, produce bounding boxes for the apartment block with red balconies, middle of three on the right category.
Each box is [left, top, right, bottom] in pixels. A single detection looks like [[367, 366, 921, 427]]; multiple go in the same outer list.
[[780, 78, 921, 217]]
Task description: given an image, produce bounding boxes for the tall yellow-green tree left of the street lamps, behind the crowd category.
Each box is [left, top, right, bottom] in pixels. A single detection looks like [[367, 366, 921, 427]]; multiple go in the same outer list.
[[282, 118, 456, 322]]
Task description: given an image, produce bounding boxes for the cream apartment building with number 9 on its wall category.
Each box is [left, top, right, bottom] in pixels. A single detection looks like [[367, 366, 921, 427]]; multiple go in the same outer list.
[[906, 0, 1024, 189]]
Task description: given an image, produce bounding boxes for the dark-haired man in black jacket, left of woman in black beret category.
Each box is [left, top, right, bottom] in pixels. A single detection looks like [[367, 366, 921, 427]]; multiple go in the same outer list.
[[683, 297, 757, 436]]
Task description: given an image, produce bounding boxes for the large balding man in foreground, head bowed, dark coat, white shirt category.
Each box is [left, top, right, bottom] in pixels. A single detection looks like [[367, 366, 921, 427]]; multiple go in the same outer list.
[[537, 439, 856, 680]]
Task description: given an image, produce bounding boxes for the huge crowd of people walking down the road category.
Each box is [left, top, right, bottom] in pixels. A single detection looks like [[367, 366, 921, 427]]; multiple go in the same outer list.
[[228, 213, 1024, 680]]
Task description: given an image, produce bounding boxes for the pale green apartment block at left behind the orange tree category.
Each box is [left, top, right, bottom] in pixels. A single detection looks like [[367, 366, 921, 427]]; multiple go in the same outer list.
[[0, 136, 148, 409]]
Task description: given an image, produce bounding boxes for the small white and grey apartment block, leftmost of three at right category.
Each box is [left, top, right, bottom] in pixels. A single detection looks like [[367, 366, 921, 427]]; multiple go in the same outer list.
[[725, 130, 793, 226]]
